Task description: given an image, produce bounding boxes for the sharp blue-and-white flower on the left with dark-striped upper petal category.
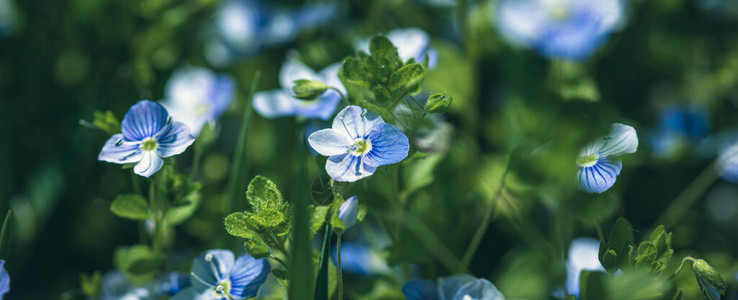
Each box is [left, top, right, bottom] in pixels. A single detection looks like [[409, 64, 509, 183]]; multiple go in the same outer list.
[[98, 100, 195, 177]]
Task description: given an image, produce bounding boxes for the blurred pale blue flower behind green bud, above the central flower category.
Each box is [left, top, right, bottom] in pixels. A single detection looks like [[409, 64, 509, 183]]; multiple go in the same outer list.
[[254, 59, 346, 120]]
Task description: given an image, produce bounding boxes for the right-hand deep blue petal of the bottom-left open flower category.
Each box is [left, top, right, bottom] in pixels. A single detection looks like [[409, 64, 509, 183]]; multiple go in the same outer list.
[[228, 254, 272, 298]]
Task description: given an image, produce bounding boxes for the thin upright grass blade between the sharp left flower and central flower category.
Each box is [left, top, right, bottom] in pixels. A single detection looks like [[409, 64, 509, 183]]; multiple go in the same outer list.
[[226, 72, 261, 211]]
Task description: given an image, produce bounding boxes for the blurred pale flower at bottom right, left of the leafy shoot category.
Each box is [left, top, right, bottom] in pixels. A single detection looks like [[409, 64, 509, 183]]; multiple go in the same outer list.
[[566, 237, 605, 297]]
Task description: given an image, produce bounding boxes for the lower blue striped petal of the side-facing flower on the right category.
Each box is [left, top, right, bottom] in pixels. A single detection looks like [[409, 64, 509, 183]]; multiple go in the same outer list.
[[577, 157, 623, 194]]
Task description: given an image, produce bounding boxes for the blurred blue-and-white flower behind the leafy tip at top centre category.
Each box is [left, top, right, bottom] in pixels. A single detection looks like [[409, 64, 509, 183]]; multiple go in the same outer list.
[[356, 28, 438, 69]]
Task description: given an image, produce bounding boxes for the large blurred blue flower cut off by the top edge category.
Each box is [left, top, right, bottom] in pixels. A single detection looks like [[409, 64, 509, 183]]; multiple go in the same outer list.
[[495, 0, 625, 60]]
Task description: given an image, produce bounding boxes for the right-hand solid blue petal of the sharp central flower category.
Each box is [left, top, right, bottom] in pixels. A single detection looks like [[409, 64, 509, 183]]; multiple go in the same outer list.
[[364, 123, 410, 167]]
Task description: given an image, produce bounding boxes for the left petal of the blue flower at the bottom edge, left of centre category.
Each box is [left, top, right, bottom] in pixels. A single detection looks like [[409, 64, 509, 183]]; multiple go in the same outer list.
[[190, 249, 235, 291]]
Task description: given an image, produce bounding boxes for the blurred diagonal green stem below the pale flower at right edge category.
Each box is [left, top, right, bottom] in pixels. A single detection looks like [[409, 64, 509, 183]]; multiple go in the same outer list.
[[653, 162, 720, 227]]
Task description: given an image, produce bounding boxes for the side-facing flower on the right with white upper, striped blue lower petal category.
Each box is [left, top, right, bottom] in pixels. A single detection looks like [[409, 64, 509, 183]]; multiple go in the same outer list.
[[577, 123, 638, 193]]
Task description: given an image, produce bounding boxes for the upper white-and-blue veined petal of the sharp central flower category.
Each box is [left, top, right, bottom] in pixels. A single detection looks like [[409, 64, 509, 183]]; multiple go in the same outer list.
[[332, 105, 384, 140]]
